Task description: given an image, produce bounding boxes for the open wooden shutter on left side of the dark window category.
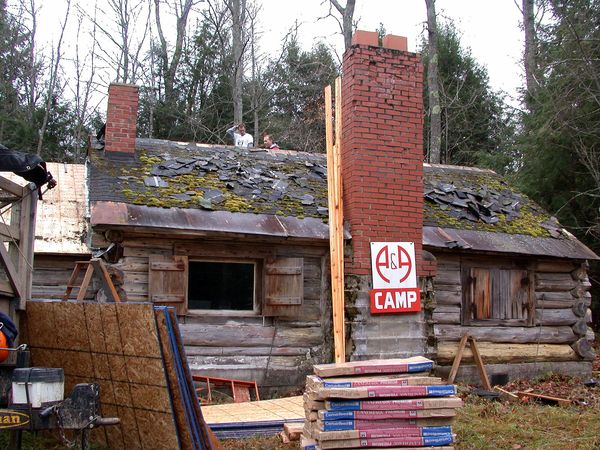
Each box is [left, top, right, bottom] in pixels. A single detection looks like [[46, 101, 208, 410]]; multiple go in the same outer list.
[[148, 255, 188, 315]]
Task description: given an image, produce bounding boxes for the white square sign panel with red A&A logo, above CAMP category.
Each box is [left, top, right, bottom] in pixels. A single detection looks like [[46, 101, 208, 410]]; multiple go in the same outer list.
[[371, 242, 417, 289]]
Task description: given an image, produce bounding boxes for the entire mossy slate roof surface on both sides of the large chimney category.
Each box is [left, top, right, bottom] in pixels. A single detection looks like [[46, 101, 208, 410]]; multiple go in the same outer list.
[[90, 139, 561, 238]]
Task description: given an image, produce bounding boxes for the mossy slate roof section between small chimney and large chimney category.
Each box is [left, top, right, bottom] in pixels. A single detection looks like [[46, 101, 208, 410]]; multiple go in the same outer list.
[[90, 139, 328, 221]]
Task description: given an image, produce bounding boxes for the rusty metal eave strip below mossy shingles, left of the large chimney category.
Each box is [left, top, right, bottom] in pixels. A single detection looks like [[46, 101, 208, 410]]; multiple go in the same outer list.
[[90, 201, 329, 243]]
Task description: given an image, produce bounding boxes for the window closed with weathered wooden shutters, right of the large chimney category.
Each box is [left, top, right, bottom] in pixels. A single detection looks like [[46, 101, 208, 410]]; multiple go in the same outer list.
[[463, 267, 535, 325]]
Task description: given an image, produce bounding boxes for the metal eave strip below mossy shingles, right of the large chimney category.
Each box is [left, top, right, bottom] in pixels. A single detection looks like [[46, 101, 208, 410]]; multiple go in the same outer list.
[[423, 227, 600, 260]]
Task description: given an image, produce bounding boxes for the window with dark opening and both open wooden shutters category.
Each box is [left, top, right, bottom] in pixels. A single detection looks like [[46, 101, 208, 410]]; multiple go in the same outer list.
[[148, 255, 304, 317]]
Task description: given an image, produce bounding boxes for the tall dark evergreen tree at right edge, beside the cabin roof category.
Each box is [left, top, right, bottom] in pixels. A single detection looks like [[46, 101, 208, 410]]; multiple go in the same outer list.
[[519, 0, 600, 243]]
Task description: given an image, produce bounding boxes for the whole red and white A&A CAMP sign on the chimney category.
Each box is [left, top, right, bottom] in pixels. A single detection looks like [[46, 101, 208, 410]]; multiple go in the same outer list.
[[371, 242, 421, 314]]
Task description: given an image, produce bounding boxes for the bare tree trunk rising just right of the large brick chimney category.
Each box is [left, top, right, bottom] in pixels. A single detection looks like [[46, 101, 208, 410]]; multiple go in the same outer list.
[[425, 0, 442, 164]]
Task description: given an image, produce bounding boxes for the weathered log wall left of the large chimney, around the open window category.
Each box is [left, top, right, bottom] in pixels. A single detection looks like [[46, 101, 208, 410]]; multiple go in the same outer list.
[[113, 238, 332, 395]]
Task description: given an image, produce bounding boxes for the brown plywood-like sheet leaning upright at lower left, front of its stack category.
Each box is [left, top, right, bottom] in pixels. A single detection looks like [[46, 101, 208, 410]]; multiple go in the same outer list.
[[25, 301, 179, 450]]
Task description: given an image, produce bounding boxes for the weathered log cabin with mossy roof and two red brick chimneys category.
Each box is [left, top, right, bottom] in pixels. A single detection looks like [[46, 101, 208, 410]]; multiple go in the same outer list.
[[82, 31, 597, 395]]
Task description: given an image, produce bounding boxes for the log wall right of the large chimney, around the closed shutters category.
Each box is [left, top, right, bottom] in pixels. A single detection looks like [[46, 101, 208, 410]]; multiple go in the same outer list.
[[433, 253, 593, 377]]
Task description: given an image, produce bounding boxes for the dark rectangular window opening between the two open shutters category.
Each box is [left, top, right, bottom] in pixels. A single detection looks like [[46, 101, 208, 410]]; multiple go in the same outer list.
[[188, 261, 255, 311]]
